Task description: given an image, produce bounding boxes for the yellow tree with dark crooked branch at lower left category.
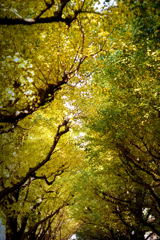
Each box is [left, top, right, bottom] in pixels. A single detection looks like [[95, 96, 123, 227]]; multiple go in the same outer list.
[[1, 97, 86, 239]]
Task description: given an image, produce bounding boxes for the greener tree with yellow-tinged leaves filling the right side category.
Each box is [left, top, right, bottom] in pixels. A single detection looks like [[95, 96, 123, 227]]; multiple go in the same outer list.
[[71, 1, 160, 239]]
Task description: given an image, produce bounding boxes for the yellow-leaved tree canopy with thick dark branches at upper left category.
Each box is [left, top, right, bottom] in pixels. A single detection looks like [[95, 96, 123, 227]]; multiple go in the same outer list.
[[0, 1, 103, 133]]
